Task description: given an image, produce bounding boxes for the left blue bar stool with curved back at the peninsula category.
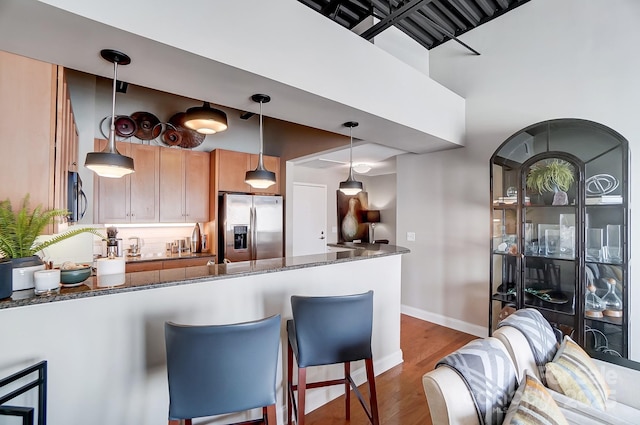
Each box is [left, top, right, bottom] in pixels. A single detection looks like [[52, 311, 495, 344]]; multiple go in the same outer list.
[[165, 315, 280, 425]]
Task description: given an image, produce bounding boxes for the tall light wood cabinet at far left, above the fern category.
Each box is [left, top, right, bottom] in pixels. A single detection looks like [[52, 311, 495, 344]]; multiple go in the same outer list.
[[0, 51, 78, 225]]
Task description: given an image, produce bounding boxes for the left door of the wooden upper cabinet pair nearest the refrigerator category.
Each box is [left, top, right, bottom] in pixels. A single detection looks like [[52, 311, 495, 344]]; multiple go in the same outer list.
[[160, 148, 185, 223]]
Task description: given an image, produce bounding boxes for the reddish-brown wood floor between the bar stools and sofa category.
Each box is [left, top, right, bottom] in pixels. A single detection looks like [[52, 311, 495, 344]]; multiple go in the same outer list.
[[305, 315, 476, 425]]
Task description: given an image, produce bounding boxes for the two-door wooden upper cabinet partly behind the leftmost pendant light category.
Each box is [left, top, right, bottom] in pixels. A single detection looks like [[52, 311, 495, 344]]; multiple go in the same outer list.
[[94, 139, 160, 223]]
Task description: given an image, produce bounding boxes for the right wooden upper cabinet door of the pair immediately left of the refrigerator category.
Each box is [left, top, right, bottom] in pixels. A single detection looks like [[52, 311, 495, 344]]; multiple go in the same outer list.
[[184, 151, 209, 222]]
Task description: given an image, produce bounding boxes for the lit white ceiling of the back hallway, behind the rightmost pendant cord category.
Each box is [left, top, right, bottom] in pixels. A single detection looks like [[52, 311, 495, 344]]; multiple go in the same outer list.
[[292, 142, 407, 176]]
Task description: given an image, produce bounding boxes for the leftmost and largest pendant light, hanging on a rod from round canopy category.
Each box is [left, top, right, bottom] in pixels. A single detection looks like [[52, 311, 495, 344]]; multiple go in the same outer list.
[[84, 49, 134, 178]]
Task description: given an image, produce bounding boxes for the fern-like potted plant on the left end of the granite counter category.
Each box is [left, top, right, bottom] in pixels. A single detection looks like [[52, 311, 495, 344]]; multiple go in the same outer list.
[[0, 195, 103, 294]]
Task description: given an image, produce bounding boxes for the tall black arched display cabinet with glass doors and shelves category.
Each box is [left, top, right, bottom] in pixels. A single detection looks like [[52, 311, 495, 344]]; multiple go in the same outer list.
[[489, 119, 630, 358]]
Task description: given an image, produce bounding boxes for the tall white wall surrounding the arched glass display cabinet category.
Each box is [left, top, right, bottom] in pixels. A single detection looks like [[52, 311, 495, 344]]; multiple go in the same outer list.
[[398, 0, 640, 359]]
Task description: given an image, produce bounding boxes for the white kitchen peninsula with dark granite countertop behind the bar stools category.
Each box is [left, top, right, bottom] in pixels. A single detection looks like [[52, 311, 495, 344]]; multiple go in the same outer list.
[[0, 244, 409, 425]]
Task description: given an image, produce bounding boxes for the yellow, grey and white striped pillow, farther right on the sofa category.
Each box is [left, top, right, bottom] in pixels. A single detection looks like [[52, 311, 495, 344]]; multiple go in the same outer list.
[[546, 336, 610, 410]]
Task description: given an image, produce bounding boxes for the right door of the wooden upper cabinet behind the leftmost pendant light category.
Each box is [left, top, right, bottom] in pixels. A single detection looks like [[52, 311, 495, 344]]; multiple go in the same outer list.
[[129, 144, 160, 223]]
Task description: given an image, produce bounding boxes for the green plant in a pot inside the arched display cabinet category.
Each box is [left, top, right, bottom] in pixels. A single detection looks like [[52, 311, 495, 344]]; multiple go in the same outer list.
[[527, 159, 575, 205]]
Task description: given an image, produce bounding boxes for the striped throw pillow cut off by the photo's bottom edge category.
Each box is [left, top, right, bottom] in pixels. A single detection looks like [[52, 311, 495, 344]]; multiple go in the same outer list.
[[503, 370, 568, 425]]
